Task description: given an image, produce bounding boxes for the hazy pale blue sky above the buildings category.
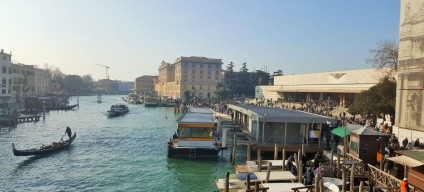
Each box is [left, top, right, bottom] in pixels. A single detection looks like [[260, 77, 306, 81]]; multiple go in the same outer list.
[[0, 0, 400, 81]]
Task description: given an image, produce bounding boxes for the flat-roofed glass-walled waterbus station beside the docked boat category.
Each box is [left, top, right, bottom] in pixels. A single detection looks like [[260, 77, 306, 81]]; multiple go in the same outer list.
[[228, 104, 336, 151]]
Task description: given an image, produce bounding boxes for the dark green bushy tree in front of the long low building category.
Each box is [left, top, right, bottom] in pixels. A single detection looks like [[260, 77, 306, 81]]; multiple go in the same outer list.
[[348, 77, 396, 116]]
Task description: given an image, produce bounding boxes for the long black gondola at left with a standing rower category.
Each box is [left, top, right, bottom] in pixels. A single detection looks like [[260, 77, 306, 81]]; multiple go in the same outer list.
[[12, 132, 77, 156]]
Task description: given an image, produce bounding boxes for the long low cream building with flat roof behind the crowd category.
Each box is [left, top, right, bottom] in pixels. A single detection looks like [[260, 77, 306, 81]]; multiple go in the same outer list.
[[255, 69, 388, 106]]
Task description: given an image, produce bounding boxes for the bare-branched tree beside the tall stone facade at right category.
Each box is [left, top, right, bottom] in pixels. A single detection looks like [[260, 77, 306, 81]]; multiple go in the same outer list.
[[366, 40, 399, 76]]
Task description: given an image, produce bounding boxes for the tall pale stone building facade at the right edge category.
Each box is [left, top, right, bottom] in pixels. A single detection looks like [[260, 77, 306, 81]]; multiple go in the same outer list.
[[393, 0, 424, 142]]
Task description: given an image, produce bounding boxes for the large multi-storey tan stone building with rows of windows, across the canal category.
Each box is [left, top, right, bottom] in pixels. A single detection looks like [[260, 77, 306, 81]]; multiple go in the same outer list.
[[155, 57, 222, 99]]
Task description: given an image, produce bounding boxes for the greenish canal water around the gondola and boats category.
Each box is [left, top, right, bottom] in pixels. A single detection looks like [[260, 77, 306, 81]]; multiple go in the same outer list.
[[0, 96, 245, 192]]
